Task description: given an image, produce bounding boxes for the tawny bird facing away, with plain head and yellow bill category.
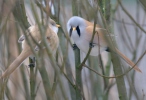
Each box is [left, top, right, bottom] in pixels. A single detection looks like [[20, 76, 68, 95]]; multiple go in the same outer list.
[[0, 18, 60, 79]]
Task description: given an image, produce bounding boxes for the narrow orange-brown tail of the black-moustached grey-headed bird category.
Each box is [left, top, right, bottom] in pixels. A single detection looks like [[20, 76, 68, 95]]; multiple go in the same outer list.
[[116, 49, 141, 72]]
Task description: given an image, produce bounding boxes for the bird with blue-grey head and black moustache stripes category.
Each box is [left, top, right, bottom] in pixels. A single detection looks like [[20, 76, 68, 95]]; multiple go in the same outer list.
[[67, 16, 142, 72]]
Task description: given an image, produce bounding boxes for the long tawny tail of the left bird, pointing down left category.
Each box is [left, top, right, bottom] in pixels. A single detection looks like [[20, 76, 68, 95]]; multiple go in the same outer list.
[[0, 49, 32, 79]]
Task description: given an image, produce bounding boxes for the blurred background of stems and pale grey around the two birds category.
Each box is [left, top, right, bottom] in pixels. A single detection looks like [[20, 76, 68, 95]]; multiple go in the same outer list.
[[0, 0, 146, 100]]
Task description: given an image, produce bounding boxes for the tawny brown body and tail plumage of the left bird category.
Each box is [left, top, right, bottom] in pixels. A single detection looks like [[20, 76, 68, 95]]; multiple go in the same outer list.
[[0, 20, 59, 78]]
